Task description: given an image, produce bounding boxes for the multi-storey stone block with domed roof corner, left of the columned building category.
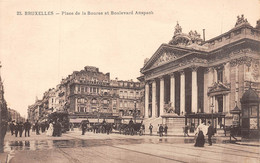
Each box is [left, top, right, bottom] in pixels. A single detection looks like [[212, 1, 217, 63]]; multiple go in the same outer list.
[[60, 66, 143, 119]]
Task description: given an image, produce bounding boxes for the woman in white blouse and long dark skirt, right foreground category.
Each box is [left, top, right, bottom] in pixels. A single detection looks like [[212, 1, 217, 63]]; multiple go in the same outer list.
[[194, 121, 207, 147]]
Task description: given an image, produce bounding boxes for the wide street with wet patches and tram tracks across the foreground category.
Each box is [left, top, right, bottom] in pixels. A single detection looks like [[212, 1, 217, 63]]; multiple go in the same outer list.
[[0, 131, 260, 163]]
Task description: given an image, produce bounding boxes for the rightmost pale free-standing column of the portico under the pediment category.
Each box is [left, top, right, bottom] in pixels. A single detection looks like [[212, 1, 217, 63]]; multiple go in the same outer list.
[[191, 67, 198, 113]]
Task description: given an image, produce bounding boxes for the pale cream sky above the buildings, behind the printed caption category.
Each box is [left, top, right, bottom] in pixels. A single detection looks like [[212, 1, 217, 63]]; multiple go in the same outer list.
[[0, 0, 260, 116]]
